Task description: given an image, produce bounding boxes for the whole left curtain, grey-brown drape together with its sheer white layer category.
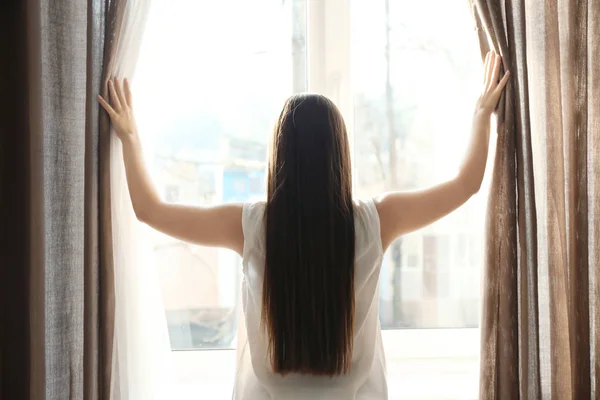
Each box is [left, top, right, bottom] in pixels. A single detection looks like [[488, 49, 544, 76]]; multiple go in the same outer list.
[[0, 0, 168, 399]]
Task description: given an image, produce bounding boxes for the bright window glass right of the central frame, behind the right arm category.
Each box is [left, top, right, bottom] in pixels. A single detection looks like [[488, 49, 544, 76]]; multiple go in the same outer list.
[[351, 0, 486, 328]]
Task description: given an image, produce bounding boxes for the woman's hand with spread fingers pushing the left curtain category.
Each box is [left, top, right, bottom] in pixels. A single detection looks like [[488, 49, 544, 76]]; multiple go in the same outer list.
[[98, 78, 137, 140]]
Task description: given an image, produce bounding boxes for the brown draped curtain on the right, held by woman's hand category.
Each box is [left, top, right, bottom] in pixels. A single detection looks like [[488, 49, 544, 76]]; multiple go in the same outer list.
[[473, 0, 600, 400]]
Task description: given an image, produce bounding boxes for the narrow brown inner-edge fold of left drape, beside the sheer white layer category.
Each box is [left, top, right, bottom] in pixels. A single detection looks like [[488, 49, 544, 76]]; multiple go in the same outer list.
[[83, 1, 114, 399]]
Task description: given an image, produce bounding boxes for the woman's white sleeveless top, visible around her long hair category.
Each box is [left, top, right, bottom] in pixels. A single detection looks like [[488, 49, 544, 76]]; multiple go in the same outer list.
[[233, 200, 388, 400]]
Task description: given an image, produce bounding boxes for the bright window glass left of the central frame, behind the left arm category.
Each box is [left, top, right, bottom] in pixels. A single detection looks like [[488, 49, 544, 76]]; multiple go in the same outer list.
[[134, 0, 306, 349]]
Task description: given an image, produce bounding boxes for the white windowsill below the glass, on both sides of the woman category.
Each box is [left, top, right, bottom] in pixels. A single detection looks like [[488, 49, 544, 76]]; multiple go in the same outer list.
[[163, 329, 479, 400]]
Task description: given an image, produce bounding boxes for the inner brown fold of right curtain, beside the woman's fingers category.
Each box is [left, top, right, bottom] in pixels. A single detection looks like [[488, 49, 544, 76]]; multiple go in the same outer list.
[[474, 0, 522, 399]]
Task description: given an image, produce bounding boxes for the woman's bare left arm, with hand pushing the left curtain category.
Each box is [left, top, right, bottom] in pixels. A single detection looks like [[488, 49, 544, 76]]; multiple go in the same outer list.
[[98, 79, 244, 254]]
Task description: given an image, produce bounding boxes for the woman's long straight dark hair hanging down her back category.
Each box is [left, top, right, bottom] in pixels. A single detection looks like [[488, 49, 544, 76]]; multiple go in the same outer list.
[[262, 94, 354, 376]]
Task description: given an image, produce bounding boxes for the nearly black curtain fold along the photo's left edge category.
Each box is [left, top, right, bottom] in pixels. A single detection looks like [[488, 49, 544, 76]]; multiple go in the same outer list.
[[0, 0, 29, 399]]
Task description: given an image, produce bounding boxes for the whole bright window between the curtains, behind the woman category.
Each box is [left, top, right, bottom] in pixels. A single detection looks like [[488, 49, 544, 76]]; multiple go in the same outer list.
[[134, 0, 485, 399]]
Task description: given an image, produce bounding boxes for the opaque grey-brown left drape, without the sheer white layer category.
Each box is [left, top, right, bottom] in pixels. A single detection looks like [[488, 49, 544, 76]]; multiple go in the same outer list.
[[0, 0, 114, 399]]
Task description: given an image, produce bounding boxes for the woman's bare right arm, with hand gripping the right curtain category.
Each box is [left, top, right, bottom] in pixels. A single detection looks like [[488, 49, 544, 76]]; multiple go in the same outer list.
[[375, 52, 509, 249]]
